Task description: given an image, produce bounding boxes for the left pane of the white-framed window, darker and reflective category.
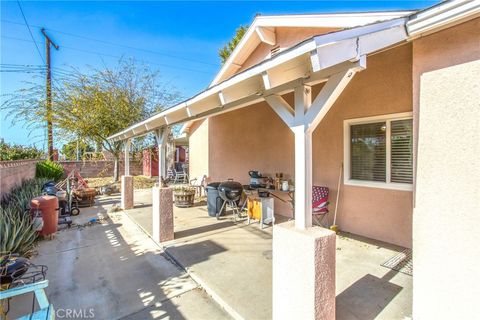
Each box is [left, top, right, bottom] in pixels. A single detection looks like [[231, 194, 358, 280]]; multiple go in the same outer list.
[[350, 122, 387, 182]]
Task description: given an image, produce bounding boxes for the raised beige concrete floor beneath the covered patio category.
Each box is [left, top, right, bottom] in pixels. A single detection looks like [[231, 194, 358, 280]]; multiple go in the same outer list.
[[127, 190, 412, 320]]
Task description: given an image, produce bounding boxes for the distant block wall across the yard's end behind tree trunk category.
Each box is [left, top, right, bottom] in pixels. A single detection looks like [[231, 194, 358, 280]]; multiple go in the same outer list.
[[59, 160, 143, 178]]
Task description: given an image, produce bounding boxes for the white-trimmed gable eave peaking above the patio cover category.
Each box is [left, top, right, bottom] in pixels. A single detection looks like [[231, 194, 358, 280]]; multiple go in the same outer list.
[[210, 11, 413, 87]]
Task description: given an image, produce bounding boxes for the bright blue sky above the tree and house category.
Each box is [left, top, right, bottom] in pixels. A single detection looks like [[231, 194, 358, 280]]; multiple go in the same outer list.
[[0, 1, 438, 148]]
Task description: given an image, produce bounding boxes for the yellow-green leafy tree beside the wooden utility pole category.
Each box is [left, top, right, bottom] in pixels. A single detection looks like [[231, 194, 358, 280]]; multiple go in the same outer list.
[[2, 59, 180, 180]]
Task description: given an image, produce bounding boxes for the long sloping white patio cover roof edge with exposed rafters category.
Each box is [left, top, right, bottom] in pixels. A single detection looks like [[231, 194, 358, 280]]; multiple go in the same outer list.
[[109, 0, 480, 141]]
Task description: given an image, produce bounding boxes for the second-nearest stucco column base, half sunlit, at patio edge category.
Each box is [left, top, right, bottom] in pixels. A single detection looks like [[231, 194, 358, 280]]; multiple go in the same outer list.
[[152, 186, 173, 242]]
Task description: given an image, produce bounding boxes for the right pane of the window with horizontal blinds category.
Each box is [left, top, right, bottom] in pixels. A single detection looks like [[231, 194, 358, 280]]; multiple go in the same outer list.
[[391, 119, 413, 183]]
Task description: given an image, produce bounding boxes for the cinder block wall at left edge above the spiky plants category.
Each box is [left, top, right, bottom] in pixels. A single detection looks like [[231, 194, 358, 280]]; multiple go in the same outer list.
[[0, 160, 39, 198]]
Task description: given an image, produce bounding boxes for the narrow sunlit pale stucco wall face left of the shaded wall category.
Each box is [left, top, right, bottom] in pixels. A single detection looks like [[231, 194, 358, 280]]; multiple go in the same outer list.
[[188, 119, 210, 179]]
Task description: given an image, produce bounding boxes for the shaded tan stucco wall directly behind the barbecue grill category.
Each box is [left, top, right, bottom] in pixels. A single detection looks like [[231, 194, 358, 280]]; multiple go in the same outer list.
[[210, 103, 294, 184]]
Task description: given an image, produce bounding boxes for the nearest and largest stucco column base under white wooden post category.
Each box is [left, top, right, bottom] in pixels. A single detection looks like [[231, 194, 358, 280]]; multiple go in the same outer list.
[[273, 221, 336, 320]]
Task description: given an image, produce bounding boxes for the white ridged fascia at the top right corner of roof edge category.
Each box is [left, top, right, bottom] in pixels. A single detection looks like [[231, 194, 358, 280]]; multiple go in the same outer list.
[[407, 0, 480, 38]]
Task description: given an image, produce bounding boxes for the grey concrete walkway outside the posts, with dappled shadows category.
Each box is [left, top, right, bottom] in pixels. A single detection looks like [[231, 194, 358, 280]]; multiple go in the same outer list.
[[9, 196, 230, 319]]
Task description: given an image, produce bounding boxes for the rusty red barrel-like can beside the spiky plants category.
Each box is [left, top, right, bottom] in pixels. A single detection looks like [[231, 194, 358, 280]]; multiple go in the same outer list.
[[30, 196, 58, 236]]
